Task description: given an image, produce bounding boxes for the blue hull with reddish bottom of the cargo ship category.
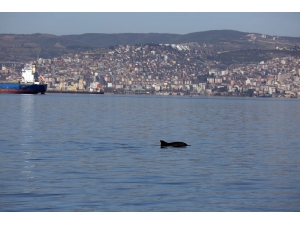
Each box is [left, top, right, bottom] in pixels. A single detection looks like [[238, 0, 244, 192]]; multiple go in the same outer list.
[[0, 83, 47, 94]]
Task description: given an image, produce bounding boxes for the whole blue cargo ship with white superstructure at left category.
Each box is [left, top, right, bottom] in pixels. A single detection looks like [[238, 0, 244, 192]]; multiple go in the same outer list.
[[0, 64, 47, 94]]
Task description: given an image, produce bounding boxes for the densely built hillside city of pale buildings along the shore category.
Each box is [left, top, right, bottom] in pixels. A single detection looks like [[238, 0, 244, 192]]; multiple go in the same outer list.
[[0, 43, 300, 97]]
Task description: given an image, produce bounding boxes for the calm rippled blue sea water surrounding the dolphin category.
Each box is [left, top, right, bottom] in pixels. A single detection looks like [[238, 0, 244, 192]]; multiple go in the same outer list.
[[0, 93, 300, 212]]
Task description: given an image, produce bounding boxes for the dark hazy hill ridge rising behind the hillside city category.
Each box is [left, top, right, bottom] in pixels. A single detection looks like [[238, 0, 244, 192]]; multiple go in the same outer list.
[[0, 30, 300, 61]]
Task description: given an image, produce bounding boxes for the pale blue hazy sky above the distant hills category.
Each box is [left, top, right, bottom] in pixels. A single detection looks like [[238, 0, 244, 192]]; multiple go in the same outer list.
[[0, 2, 300, 37]]
